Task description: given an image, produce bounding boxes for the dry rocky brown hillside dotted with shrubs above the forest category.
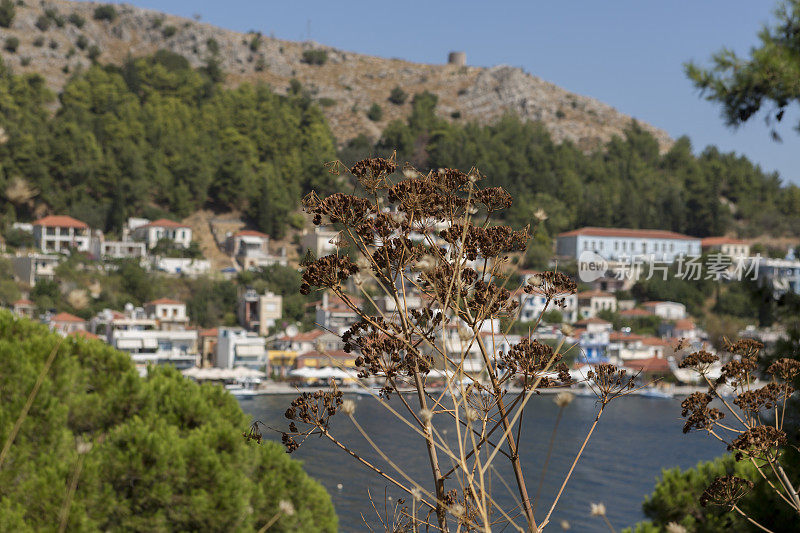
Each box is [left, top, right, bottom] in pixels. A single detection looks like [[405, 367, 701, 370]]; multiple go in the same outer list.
[[0, 0, 671, 149]]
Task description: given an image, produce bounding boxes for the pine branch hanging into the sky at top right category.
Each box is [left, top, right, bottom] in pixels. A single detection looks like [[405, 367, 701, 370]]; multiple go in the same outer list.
[[685, 0, 800, 135]]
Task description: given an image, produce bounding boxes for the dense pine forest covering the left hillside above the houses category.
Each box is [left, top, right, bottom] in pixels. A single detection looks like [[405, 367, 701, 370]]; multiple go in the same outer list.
[[0, 51, 337, 237]]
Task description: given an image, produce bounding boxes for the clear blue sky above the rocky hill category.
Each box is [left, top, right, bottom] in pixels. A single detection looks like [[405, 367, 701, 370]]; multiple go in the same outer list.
[[103, 0, 800, 184]]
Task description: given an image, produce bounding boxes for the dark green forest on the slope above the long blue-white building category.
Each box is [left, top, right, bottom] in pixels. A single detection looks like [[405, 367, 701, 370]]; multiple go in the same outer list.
[[368, 93, 800, 238]]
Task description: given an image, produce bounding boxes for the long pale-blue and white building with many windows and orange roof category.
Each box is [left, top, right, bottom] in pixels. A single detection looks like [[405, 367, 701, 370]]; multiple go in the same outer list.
[[556, 227, 701, 263]]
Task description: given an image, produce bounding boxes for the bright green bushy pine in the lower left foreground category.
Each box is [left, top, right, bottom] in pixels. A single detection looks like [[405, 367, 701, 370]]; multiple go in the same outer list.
[[0, 311, 337, 532]]
